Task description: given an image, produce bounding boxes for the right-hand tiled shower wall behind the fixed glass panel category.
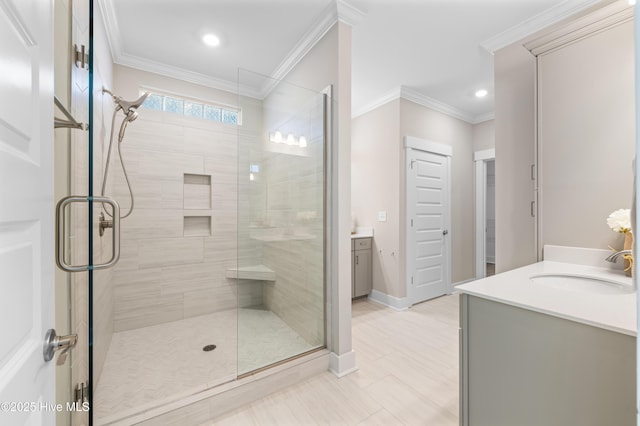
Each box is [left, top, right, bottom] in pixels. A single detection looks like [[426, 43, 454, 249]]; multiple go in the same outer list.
[[263, 145, 324, 345]]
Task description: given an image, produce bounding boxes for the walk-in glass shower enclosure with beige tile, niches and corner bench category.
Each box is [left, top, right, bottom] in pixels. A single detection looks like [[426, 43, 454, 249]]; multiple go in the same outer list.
[[86, 63, 330, 425]]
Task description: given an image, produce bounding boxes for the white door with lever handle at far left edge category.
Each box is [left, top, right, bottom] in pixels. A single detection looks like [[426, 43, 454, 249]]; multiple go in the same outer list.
[[0, 0, 55, 425]]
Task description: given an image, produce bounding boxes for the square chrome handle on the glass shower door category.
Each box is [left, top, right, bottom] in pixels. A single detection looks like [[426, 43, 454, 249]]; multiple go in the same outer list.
[[56, 195, 120, 272]]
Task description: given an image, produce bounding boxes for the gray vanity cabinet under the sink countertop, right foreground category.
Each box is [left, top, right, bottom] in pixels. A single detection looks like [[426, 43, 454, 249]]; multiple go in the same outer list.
[[460, 294, 636, 426]]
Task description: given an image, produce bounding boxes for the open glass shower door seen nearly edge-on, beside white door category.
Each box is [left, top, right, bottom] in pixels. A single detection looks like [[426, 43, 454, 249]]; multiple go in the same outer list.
[[53, 0, 93, 425]]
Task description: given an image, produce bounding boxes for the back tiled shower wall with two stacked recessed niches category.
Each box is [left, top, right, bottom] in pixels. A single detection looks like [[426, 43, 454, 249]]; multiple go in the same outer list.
[[108, 105, 242, 331]]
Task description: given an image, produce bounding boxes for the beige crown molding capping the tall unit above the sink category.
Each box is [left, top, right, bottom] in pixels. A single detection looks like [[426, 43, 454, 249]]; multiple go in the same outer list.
[[524, 2, 634, 56]]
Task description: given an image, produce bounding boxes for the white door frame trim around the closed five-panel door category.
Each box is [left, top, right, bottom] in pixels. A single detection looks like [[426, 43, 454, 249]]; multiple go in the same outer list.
[[404, 136, 454, 306]]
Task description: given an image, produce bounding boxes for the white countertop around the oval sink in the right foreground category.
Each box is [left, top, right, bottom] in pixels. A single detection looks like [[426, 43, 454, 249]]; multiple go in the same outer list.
[[456, 260, 637, 336]]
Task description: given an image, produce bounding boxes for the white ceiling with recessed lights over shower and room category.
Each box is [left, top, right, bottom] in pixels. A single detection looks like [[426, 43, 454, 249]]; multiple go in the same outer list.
[[100, 0, 598, 122]]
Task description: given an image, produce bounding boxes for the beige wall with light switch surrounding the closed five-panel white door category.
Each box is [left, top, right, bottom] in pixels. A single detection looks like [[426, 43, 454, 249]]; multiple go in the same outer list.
[[351, 95, 474, 298]]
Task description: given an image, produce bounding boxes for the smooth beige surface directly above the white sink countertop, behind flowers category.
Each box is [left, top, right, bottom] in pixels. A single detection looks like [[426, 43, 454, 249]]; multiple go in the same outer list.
[[538, 21, 636, 253]]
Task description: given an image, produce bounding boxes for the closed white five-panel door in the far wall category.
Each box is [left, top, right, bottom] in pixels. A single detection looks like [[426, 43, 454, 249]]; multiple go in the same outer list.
[[407, 141, 450, 303]]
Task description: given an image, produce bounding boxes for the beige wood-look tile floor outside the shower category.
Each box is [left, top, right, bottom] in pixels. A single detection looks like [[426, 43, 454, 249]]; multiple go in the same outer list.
[[207, 294, 459, 426]]
